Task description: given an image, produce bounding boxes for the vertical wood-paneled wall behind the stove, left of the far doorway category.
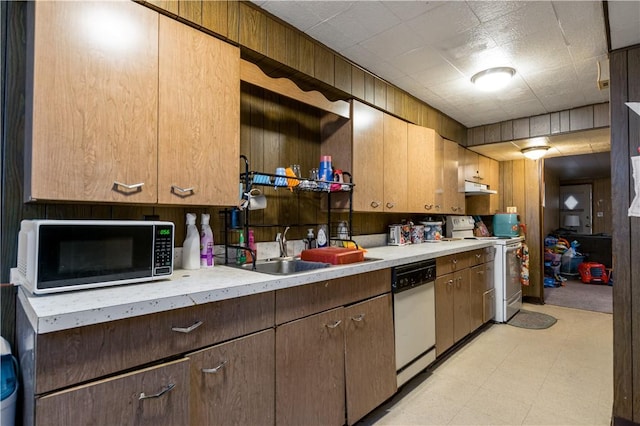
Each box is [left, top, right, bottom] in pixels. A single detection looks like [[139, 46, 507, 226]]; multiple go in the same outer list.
[[498, 160, 544, 303]]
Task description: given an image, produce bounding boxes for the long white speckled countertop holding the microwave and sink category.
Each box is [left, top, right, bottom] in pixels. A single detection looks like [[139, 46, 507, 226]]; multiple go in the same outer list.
[[18, 240, 493, 334]]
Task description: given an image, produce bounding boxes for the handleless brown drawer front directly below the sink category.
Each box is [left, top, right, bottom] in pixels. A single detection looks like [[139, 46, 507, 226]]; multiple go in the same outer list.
[[276, 269, 391, 324]]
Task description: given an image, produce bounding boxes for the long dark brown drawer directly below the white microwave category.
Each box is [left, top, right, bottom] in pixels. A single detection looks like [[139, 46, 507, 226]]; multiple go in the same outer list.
[[35, 292, 274, 394]]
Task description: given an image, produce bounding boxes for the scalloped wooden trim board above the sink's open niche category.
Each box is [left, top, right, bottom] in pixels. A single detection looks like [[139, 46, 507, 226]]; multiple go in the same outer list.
[[240, 60, 350, 118]]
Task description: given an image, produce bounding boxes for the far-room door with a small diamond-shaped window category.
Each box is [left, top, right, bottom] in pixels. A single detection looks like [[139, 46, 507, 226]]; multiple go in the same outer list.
[[560, 184, 593, 234]]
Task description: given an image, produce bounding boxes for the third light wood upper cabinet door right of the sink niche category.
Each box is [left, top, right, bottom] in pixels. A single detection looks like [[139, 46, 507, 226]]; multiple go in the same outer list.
[[407, 124, 436, 213]]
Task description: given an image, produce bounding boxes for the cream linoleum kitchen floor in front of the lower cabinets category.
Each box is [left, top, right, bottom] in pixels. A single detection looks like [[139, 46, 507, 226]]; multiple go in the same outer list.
[[360, 304, 613, 426]]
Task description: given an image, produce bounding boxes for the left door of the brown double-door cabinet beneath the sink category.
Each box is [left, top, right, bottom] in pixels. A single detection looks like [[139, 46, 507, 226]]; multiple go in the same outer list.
[[276, 308, 345, 426]]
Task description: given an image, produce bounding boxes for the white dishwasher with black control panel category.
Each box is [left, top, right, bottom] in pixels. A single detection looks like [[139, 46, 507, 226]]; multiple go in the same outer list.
[[392, 259, 436, 387]]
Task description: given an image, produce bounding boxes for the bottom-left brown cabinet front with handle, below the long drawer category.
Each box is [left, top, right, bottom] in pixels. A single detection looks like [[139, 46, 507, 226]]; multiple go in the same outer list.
[[35, 359, 189, 426]]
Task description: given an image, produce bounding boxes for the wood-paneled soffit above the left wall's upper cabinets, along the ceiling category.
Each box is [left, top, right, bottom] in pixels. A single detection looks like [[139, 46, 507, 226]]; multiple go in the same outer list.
[[136, 0, 467, 145]]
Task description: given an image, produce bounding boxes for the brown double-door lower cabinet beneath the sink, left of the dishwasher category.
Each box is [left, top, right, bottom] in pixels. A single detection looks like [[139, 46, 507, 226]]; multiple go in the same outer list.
[[276, 293, 397, 425]]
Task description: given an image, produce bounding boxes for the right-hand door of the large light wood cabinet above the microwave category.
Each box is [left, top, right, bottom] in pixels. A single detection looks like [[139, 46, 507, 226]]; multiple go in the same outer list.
[[158, 16, 240, 206]]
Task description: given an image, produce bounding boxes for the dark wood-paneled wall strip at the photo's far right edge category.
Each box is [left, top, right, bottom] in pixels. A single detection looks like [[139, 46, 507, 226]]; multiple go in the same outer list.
[[609, 46, 640, 425]]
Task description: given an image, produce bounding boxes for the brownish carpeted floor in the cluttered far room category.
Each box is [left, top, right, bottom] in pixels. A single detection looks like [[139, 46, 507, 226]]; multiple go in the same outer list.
[[544, 279, 613, 314]]
